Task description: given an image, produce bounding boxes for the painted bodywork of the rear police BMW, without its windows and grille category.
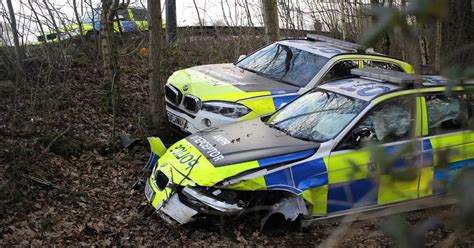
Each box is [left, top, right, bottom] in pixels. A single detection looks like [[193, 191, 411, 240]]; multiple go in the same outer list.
[[166, 40, 414, 134]]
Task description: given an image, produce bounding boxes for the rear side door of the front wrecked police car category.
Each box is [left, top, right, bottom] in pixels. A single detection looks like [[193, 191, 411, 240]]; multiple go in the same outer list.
[[420, 93, 474, 196]]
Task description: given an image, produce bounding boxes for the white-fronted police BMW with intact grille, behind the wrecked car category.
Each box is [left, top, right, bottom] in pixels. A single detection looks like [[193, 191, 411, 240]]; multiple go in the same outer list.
[[166, 34, 414, 134]]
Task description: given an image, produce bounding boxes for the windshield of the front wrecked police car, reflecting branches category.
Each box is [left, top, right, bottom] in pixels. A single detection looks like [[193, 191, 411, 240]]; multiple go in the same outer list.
[[268, 90, 368, 142]]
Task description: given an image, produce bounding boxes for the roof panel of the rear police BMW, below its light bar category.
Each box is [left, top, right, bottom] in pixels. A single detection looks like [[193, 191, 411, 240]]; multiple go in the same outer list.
[[278, 39, 357, 58]]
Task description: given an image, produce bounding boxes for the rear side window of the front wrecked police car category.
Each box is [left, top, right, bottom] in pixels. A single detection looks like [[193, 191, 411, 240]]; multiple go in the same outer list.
[[426, 94, 473, 135]]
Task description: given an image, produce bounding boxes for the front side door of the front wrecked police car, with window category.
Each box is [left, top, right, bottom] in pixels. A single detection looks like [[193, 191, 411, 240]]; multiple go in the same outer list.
[[327, 96, 422, 213]]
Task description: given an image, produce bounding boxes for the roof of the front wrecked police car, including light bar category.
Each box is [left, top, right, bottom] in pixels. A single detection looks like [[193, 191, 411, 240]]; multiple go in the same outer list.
[[318, 68, 474, 101]]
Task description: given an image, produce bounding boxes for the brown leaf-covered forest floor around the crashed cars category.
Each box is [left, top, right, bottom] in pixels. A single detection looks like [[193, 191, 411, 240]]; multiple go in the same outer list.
[[0, 40, 474, 247]]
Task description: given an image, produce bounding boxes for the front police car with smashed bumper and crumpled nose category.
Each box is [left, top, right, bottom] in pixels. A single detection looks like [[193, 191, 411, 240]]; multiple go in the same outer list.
[[145, 68, 474, 229]]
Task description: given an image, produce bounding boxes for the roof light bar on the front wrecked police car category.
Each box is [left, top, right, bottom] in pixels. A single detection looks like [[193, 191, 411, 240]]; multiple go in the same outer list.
[[351, 67, 421, 85]]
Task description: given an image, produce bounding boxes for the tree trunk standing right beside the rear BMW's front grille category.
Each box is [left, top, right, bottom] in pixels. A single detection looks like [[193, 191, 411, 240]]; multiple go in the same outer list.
[[148, 0, 166, 134]]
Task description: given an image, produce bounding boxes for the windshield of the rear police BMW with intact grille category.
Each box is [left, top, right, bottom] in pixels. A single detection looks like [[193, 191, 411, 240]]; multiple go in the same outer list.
[[237, 43, 329, 87]]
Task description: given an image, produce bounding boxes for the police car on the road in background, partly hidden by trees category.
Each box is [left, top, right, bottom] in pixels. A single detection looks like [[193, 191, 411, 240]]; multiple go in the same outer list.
[[37, 7, 148, 42]]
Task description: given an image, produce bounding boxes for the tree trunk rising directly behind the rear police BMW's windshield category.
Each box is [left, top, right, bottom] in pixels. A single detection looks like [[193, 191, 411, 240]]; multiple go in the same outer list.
[[262, 0, 280, 43]]
